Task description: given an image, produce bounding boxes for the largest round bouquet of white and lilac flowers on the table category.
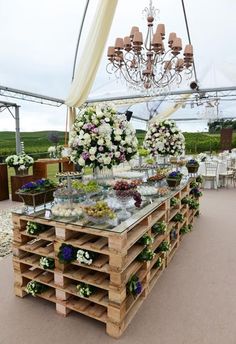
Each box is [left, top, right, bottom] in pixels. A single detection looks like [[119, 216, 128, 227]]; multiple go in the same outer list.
[[69, 106, 138, 169]]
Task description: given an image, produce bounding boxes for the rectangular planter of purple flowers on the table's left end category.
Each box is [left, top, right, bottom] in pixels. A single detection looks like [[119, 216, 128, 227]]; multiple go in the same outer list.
[[16, 178, 56, 209]]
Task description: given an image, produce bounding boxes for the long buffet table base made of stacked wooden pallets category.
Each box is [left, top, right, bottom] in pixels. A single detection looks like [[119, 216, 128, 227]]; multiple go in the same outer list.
[[13, 181, 197, 338]]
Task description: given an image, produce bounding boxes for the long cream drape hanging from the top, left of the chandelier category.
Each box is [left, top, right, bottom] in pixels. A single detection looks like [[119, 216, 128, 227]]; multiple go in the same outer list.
[[65, 0, 118, 109]]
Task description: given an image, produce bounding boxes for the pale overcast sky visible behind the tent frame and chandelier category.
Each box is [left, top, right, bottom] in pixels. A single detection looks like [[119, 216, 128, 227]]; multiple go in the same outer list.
[[0, 0, 236, 131]]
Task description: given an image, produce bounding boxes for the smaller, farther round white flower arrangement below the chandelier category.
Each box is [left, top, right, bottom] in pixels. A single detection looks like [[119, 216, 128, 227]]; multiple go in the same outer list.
[[144, 117, 185, 156]]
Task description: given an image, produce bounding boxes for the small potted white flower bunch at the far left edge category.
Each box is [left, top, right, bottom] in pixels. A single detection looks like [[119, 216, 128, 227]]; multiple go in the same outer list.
[[5, 152, 34, 175]]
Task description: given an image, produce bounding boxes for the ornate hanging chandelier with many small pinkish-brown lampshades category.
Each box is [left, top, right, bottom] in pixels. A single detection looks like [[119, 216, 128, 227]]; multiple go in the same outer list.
[[107, 0, 193, 92]]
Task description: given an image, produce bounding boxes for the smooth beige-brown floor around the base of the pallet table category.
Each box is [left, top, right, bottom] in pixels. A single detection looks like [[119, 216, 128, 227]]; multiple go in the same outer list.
[[0, 189, 236, 344]]
